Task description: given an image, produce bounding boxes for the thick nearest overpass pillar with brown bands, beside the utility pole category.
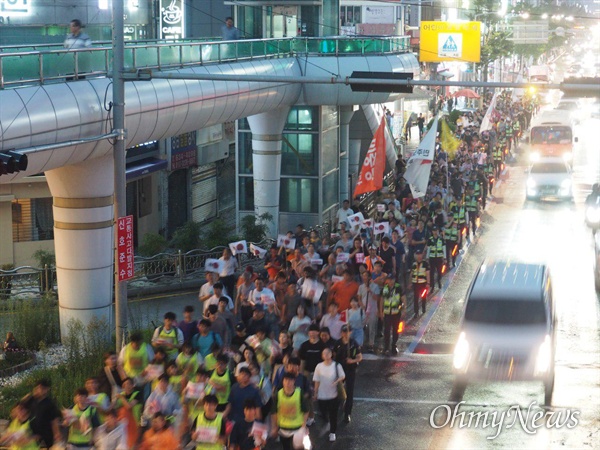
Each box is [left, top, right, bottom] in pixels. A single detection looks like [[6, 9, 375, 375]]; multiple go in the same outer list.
[[46, 155, 114, 338]]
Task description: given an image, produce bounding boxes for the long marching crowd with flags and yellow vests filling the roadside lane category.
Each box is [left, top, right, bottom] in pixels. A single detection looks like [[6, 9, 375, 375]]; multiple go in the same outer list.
[[2, 92, 536, 450]]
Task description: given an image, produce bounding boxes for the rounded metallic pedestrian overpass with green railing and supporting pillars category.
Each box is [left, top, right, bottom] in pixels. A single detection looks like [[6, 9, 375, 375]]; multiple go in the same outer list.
[[0, 36, 419, 330]]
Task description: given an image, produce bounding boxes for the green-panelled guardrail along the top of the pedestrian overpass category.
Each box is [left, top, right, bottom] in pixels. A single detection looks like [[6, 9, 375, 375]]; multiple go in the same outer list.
[[0, 36, 410, 89]]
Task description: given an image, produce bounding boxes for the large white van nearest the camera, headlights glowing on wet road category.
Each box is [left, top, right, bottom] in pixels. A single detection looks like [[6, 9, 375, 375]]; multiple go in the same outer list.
[[452, 260, 556, 405]]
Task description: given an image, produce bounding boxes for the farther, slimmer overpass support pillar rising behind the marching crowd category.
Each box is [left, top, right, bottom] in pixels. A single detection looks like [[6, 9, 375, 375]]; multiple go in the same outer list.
[[248, 107, 289, 237]]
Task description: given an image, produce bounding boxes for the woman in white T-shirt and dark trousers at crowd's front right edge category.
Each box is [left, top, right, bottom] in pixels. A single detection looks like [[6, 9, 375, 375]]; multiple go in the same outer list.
[[313, 348, 346, 442]]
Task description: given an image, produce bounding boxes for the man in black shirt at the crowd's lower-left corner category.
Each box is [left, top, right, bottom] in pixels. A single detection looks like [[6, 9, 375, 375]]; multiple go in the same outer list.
[[31, 379, 62, 448]]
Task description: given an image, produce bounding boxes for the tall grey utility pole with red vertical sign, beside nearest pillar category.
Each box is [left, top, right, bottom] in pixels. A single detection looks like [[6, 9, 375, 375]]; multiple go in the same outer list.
[[112, 0, 127, 352]]
